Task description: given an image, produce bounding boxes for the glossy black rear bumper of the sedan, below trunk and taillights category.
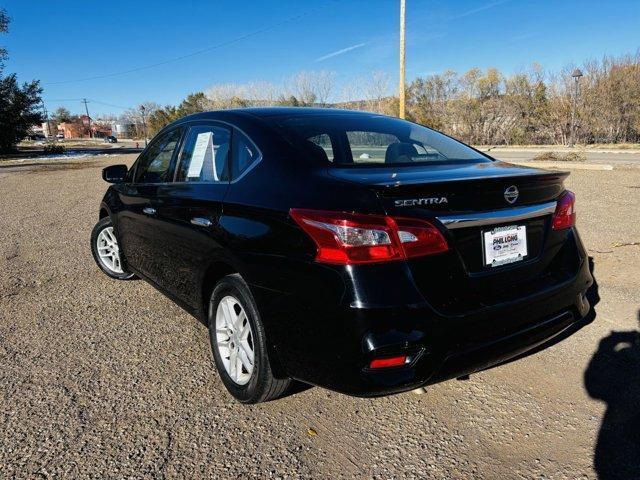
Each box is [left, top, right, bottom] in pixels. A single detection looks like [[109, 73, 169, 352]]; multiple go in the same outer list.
[[250, 229, 593, 397]]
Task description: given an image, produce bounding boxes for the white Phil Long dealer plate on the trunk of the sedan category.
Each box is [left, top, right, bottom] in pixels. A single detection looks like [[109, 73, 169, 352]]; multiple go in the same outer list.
[[482, 225, 527, 267]]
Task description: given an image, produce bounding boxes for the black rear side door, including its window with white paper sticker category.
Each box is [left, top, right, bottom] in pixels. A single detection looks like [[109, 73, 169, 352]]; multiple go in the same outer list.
[[146, 121, 231, 308]]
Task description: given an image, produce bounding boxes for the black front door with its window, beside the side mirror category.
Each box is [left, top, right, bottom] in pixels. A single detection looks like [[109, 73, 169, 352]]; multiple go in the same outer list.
[[117, 127, 185, 283]]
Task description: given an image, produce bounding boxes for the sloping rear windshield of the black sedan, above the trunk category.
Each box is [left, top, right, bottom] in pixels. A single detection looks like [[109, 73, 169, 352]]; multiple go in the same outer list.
[[276, 114, 491, 167]]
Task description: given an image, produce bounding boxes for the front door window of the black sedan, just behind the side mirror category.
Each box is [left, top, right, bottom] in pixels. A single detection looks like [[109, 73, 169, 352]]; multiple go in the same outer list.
[[136, 128, 183, 183]]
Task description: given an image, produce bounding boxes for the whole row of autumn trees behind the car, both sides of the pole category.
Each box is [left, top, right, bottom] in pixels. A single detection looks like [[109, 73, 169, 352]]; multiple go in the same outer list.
[[138, 50, 640, 145]]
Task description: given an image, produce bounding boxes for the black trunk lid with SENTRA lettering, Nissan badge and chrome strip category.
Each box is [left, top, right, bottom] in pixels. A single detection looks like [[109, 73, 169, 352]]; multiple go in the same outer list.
[[330, 161, 568, 314]]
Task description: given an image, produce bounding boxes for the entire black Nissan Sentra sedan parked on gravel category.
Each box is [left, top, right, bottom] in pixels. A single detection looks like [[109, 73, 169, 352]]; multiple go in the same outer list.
[[91, 108, 593, 403]]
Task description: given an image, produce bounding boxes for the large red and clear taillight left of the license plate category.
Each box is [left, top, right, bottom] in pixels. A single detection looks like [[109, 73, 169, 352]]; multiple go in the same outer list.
[[290, 208, 449, 265]]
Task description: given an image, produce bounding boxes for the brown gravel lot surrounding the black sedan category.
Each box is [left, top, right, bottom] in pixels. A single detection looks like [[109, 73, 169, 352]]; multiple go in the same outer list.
[[0, 155, 640, 479]]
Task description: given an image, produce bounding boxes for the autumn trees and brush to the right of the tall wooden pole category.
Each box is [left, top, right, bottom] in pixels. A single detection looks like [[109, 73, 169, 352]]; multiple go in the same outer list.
[[408, 50, 640, 145]]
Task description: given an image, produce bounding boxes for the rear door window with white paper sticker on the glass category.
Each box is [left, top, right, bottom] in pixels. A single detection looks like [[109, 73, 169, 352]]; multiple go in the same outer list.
[[176, 125, 231, 182]]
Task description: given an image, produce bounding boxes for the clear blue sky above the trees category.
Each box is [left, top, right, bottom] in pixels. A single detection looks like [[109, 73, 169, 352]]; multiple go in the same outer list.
[[0, 0, 640, 114]]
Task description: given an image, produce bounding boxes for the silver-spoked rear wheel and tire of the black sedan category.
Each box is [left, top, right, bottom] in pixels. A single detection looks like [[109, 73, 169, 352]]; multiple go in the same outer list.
[[208, 274, 291, 403]]
